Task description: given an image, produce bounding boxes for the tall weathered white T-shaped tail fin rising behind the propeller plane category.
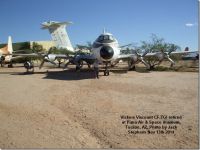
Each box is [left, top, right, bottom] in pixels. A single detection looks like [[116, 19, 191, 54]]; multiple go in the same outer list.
[[42, 21, 74, 51]]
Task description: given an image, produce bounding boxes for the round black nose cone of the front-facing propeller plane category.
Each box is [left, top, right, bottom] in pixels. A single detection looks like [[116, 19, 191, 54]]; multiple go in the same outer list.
[[100, 46, 114, 59]]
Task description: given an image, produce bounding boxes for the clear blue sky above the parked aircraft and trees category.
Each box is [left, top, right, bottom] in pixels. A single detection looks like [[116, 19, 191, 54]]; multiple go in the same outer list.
[[0, 0, 198, 50]]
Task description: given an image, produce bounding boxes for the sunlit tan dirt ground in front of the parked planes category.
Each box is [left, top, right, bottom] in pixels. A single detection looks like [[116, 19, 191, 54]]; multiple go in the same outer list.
[[0, 63, 198, 148]]
